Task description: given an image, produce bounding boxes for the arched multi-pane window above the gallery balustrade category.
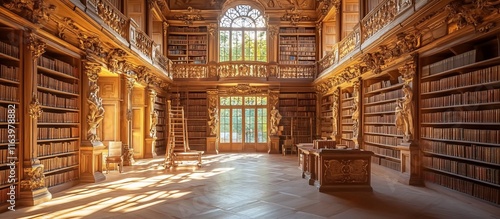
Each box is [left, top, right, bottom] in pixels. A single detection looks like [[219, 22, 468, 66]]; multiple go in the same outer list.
[[219, 5, 267, 62]]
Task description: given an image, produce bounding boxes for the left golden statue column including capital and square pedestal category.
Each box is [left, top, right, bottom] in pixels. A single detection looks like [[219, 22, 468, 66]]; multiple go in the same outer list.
[[80, 60, 106, 182]]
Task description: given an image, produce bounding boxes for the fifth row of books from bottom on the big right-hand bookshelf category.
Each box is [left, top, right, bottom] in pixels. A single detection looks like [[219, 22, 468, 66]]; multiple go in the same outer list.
[[422, 109, 500, 126]]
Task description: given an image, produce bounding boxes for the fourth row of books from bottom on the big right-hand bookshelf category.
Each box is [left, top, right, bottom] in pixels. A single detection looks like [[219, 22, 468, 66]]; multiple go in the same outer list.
[[420, 127, 500, 144]]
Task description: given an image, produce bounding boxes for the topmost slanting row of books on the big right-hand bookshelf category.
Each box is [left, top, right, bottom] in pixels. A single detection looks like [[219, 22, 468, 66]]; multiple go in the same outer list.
[[422, 50, 476, 76]]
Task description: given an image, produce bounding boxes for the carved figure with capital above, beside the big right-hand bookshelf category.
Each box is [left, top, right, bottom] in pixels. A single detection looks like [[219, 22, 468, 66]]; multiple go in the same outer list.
[[395, 61, 416, 142]]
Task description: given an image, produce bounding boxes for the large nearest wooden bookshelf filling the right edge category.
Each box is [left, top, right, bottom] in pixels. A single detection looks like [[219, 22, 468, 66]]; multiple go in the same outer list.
[[419, 36, 500, 204]]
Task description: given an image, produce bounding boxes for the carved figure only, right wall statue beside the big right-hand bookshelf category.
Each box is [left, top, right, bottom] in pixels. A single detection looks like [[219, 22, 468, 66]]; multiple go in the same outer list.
[[395, 84, 414, 142]]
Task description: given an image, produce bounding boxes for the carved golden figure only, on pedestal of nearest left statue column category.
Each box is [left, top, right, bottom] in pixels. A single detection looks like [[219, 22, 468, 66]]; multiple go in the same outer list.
[[87, 83, 104, 143]]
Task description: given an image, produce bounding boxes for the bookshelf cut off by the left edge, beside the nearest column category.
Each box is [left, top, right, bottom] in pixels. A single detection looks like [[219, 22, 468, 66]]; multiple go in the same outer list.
[[0, 27, 23, 212]]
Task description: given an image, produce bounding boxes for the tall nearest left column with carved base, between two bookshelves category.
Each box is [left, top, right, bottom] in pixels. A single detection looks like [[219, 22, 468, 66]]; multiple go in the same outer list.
[[18, 33, 52, 206]]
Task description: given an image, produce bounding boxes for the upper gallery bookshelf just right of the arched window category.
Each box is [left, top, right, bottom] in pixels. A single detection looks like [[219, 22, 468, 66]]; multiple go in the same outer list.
[[279, 27, 316, 65]]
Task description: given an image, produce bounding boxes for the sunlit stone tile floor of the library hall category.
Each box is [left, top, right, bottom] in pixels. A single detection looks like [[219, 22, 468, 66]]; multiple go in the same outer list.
[[0, 153, 500, 219]]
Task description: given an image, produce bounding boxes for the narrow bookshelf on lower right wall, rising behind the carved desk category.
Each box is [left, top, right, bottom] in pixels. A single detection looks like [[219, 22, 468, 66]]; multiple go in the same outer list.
[[338, 87, 354, 148]]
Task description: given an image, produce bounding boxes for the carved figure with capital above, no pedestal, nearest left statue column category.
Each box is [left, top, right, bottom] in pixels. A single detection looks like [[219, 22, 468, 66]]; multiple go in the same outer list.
[[84, 62, 104, 144]]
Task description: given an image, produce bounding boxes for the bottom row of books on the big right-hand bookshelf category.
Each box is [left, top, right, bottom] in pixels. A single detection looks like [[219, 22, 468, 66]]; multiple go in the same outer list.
[[424, 171, 500, 204]]
